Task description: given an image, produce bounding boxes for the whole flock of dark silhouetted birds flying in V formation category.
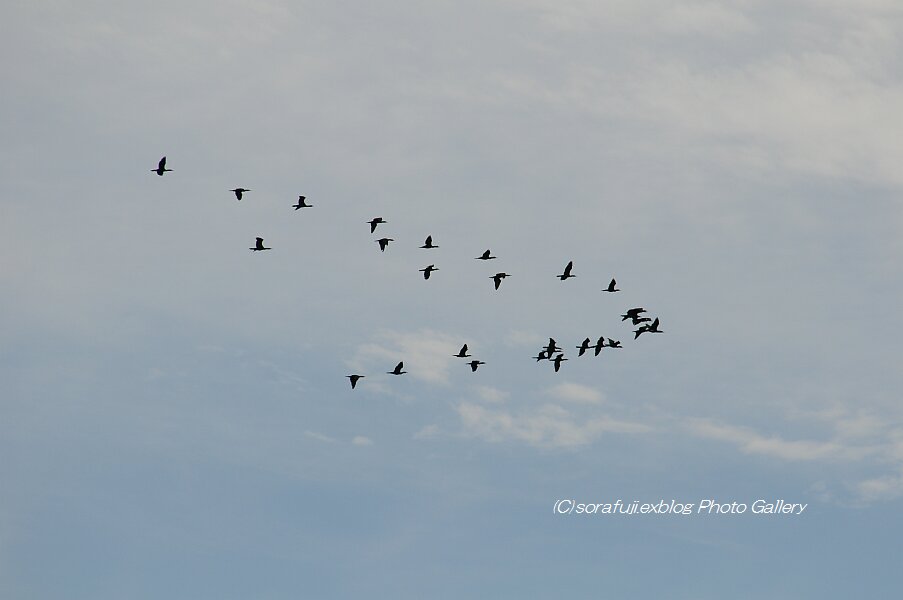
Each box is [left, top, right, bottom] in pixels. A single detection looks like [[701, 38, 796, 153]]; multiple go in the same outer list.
[[151, 156, 663, 389]]
